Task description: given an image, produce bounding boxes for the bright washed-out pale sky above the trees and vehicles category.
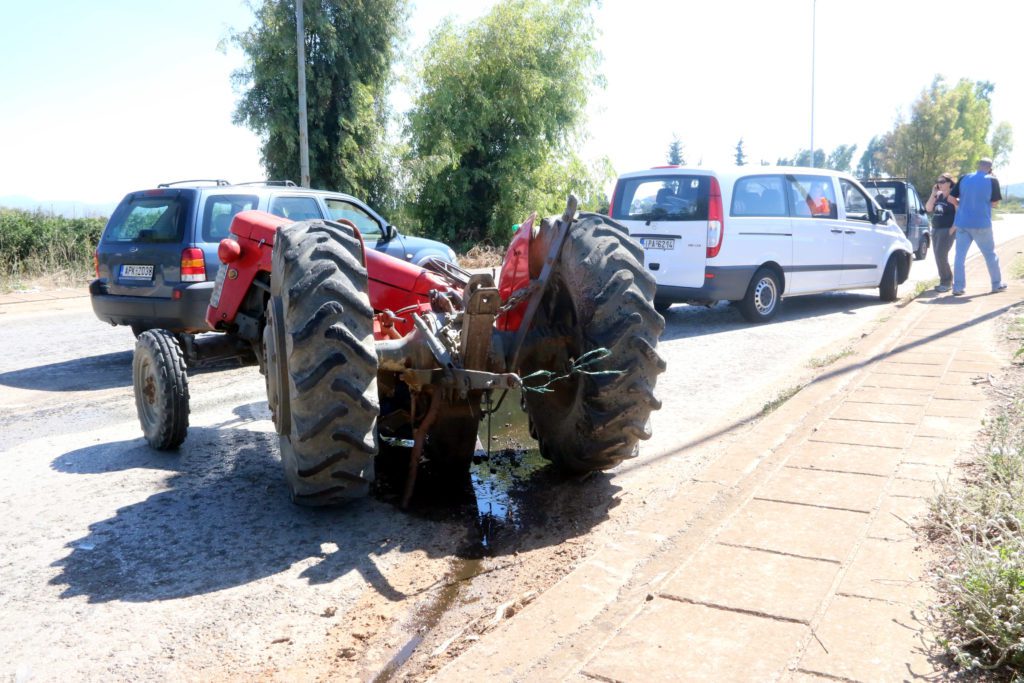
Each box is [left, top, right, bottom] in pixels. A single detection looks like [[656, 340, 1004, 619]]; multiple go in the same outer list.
[[0, 0, 1024, 203]]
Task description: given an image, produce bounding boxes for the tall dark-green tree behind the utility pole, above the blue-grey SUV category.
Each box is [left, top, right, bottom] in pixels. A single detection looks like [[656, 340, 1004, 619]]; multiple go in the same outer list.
[[231, 0, 406, 206]]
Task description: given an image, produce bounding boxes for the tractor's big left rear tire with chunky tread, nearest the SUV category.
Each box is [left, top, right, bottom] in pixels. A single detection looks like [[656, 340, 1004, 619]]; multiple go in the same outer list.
[[263, 220, 380, 506]]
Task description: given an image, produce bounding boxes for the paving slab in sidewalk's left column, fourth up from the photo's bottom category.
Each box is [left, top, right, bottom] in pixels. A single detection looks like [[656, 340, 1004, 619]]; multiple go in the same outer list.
[[755, 467, 887, 512]]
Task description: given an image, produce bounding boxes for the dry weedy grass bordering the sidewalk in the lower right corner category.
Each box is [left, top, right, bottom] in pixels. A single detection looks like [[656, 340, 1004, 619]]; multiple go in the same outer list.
[[929, 329, 1024, 680]]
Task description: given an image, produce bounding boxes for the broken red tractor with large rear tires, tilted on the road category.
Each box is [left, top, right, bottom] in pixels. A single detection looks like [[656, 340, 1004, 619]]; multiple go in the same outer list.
[[133, 197, 665, 505]]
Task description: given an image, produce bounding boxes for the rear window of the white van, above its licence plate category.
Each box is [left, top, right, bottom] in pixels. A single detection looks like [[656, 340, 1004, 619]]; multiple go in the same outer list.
[[611, 174, 711, 221]]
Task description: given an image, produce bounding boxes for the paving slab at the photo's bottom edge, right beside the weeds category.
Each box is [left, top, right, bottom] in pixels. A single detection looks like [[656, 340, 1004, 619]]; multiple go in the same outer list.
[[798, 596, 945, 681]]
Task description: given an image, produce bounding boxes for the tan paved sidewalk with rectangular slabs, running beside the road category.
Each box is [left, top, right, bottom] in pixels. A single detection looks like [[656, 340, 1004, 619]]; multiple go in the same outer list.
[[435, 240, 1024, 682]]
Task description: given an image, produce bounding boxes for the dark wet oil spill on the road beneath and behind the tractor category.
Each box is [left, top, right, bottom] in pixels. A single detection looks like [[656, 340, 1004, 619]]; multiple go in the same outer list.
[[374, 394, 547, 683]]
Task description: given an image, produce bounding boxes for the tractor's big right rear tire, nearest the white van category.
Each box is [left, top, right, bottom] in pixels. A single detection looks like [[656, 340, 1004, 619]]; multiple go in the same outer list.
[[518, 213, 665, 472]]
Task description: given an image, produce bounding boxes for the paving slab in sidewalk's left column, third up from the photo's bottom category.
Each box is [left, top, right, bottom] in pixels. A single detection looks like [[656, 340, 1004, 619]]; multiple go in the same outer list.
[[718, 500, 869, 562]]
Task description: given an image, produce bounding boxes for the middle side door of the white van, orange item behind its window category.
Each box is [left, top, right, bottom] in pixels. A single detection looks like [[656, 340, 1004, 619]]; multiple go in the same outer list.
[[785, 174, 844, 294]]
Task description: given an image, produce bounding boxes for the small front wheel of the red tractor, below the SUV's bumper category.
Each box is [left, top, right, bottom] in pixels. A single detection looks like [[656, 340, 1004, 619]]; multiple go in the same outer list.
[[131, 330, 188, 451]]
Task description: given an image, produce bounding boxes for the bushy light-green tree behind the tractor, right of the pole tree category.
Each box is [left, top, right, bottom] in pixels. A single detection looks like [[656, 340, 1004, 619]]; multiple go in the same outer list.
[[409, 0, 610, 245]]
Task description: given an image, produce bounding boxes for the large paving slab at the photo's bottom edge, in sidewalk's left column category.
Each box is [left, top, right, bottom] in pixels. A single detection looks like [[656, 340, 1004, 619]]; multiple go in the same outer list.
[[583, 598, 808, 683]]
